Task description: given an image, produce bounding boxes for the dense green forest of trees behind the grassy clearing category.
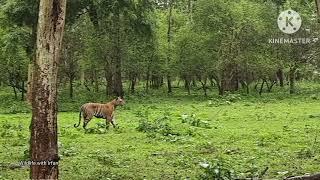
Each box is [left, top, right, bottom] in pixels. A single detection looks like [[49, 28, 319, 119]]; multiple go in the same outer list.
[[0, 0, 320, 100]]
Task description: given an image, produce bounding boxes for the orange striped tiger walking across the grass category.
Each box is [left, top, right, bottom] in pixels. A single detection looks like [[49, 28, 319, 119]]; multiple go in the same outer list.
[[74, 97, 125, 129]]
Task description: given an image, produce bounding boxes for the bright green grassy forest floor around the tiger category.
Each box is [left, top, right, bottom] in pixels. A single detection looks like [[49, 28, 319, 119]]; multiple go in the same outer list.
[[0, 82, 320, 180]]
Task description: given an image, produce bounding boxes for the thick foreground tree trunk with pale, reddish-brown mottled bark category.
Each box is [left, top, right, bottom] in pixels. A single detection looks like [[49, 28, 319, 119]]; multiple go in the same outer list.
[[30, 0, 66, 179]]
